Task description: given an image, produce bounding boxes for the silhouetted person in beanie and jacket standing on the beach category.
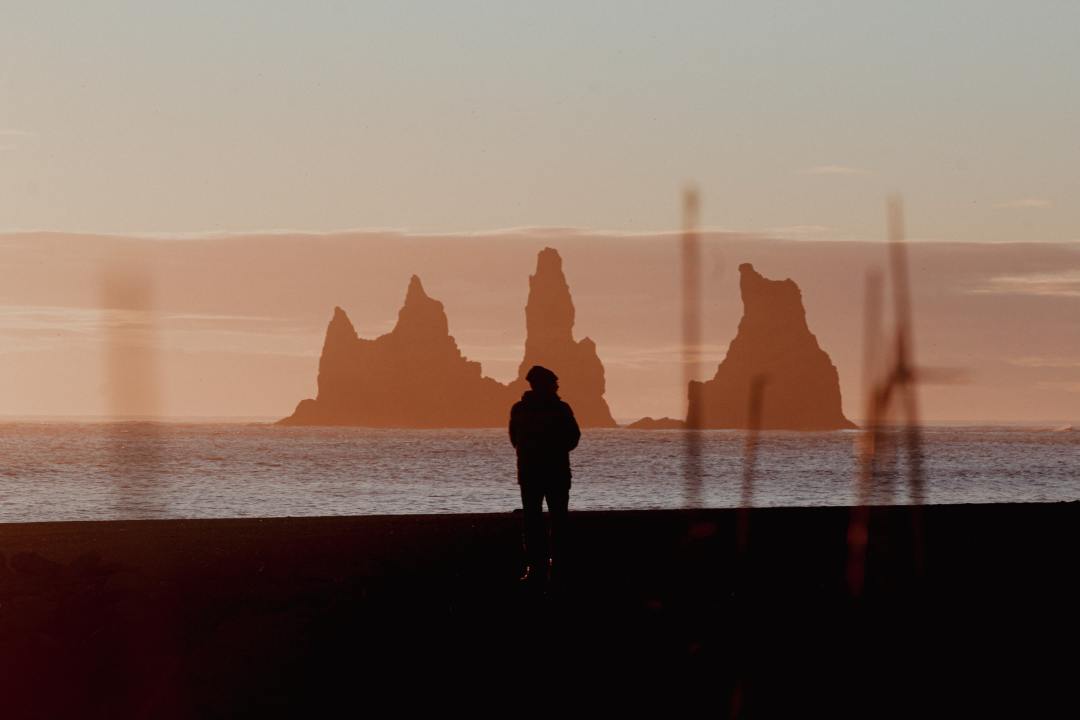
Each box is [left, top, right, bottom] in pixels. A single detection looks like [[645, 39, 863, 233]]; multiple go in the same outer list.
[[510, 365, 581, 582]]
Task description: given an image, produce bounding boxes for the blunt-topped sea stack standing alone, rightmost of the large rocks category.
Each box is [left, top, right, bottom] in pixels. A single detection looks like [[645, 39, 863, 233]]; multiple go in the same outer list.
[[687, 263, 855, 430]]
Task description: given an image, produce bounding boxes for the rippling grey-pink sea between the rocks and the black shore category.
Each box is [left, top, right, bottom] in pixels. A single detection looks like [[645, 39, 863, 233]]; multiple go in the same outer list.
[[0, 422, 1080, 522]]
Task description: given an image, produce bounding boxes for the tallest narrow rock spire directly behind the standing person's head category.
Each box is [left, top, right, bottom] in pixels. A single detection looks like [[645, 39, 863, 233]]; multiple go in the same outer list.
[[510, 247, 616, 427]]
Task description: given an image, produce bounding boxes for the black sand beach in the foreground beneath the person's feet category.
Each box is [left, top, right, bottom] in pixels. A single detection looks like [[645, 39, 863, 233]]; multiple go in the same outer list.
[[0, 503, 1080, 718]]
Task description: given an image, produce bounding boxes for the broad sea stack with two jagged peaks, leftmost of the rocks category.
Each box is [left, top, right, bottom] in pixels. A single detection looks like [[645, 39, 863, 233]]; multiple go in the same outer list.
[[281, 275, 514, 427]]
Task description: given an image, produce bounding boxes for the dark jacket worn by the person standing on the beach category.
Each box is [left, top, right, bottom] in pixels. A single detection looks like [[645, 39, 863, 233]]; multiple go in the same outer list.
[[510, 390, 581, 485]]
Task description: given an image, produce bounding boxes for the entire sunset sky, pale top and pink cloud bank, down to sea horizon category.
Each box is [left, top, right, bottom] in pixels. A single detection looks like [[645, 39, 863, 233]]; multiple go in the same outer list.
[[0, 0, 1080, 421]]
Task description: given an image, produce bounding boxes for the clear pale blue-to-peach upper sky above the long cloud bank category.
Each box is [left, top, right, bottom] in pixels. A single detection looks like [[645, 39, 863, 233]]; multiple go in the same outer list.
[[0, 0, 1080, 242]]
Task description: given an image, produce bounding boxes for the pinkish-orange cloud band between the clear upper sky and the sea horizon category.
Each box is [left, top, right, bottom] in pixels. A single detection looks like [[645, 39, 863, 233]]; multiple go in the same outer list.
[[0, 230, 1080, 426]]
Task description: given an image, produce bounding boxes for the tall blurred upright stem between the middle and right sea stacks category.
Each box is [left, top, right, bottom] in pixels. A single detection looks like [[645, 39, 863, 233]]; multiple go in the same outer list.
[[681, 186, 703, 507]]
